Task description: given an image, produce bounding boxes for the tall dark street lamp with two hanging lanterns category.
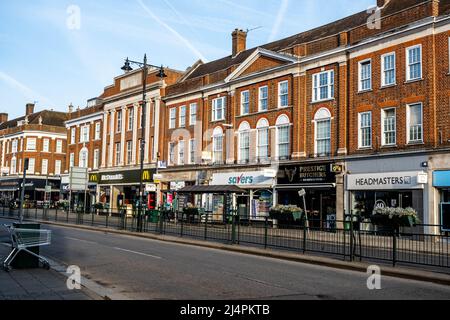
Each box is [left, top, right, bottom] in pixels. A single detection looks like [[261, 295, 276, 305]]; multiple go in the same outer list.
[[121, 54, 167, 232]]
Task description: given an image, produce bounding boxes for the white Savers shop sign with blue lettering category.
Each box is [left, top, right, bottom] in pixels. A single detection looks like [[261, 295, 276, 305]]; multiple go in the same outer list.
[[211, 171, 273, 187]]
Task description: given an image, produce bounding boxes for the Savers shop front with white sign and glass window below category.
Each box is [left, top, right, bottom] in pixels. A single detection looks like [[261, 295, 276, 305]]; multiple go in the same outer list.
[[211, 170, 276, 220]]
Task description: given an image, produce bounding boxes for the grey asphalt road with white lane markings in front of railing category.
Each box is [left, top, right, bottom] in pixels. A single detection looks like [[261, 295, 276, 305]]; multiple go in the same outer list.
[[0, 219, 450, 300]]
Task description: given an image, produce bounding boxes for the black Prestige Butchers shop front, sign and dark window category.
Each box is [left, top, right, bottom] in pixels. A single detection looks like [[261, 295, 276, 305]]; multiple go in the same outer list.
[[275, 163, 342, 227]]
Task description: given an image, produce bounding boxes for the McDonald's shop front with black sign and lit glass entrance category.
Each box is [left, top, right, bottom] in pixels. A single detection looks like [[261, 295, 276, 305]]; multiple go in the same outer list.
[[89, 169, 156, 211]]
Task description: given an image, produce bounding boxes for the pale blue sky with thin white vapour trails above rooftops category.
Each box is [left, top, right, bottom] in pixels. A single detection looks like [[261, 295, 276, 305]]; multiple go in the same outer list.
[[0, 0, 376, 119]]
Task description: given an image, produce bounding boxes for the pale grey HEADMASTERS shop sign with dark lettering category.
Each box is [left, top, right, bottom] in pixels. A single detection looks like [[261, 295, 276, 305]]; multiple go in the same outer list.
[[347, 171, 427, 191]]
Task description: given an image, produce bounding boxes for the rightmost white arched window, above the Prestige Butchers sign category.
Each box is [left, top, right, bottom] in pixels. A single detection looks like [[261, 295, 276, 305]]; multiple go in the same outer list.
[[314, 108, 331, 157]]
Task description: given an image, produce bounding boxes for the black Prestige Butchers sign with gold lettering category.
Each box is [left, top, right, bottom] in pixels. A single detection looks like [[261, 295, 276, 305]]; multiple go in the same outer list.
[[278, 163, 336, 185]]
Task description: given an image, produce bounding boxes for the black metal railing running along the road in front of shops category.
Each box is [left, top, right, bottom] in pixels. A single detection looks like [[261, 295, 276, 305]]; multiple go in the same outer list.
[[0, 206, 450, 270]]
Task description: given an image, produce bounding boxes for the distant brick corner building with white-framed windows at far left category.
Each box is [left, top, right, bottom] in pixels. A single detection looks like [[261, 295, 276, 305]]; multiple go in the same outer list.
[[0, 104, 67, 201]]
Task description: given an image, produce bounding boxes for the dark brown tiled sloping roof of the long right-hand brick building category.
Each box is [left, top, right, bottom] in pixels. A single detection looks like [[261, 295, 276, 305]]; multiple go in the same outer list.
[[184, 0, 434, 80]]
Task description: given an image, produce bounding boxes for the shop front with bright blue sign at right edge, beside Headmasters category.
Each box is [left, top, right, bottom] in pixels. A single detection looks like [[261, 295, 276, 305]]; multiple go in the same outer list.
[[433, 170, 450, 232]]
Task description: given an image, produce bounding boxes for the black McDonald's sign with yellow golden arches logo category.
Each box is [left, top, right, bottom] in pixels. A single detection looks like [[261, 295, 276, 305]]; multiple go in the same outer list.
[[93, 169, 154, 185]]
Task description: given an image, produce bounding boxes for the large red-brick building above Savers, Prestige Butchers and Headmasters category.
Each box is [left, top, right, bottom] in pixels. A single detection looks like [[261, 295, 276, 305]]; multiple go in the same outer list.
[[161, 0, 450, 232]]
